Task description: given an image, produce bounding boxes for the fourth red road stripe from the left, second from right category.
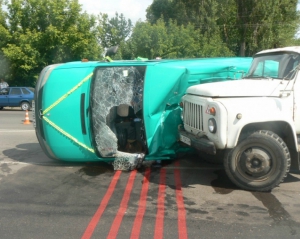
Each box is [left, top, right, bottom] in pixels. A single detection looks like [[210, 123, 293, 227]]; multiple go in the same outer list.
[[154, 168, 166, 239]]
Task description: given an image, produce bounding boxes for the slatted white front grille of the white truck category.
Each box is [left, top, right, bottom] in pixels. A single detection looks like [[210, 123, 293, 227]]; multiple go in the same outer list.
[[183, 101, 203, 131]]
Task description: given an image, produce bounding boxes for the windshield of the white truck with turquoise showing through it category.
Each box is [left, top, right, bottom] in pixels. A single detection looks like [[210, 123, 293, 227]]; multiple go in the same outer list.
[[244, 52, 300, 80]]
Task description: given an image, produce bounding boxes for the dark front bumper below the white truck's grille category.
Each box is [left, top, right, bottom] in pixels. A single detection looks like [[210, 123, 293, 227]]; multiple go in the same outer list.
[[179, 129, 217, 154]]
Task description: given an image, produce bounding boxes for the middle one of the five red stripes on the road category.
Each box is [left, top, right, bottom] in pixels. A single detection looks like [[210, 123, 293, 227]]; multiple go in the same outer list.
[[130, 168, 151, 239]]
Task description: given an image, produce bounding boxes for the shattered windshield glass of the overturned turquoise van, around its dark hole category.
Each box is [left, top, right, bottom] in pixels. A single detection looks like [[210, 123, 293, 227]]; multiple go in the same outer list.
[[91, 66, 145, 160]]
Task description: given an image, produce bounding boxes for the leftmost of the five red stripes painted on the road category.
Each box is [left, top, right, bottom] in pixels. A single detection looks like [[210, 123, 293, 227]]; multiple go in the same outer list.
[[81, 171, 122, 239]]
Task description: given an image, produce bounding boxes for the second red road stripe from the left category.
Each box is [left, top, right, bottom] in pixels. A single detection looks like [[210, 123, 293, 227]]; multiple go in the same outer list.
[[107, 170, 137, 239]]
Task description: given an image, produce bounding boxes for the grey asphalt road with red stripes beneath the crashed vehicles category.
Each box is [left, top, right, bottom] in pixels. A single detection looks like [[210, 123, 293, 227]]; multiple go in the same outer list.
[[0, 109, 300, 239]]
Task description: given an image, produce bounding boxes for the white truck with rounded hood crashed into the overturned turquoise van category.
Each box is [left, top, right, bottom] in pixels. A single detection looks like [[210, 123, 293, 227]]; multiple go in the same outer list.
[[179, 46, 300, 191]]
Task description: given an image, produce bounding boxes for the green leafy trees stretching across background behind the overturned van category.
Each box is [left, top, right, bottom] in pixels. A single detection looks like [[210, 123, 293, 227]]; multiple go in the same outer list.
[[0, 0, 300, 86]]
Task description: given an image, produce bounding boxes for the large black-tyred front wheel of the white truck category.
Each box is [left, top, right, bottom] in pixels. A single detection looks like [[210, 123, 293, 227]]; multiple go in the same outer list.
[[224, 130, 291, 191]]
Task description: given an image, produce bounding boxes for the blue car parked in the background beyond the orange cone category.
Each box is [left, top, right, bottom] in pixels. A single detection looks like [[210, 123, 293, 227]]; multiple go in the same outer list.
[[0, 87, 34, 110]]
